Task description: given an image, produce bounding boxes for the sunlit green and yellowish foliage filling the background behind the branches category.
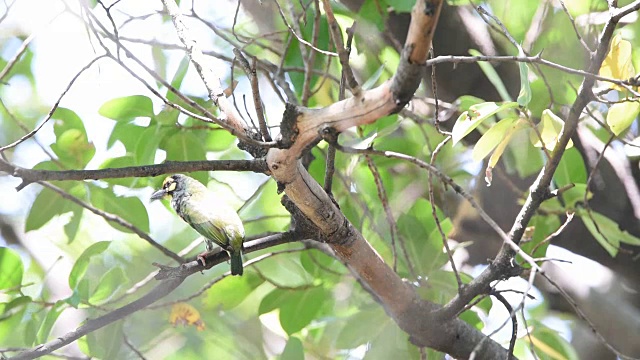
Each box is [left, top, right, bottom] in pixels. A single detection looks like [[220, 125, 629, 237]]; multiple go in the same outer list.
[[0, 0, 640, 359]]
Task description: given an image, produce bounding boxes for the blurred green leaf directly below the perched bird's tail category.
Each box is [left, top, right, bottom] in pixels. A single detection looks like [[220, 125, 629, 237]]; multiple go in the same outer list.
[[203, 271, 264, 311]]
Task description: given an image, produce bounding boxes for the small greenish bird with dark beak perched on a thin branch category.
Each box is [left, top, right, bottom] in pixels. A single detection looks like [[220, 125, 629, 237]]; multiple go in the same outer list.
[[151, 174, 244, 275]]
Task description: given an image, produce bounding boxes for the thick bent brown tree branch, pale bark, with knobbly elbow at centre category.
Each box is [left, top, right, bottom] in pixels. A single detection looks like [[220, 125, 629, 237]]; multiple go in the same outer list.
[[267, 1, 507, 358]]
